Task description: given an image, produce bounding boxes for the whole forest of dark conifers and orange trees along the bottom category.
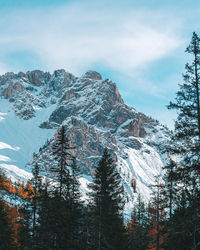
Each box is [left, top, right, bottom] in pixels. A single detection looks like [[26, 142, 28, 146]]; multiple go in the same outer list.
[[0, 33, 200, 250]]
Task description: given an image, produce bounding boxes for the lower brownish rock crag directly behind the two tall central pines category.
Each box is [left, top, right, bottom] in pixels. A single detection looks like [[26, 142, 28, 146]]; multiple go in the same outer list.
[[35, 117, 118, 175]]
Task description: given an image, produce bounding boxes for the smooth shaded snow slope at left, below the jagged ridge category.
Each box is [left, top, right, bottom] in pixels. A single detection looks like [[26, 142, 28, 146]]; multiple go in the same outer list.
[[0, 99, 55, 181]]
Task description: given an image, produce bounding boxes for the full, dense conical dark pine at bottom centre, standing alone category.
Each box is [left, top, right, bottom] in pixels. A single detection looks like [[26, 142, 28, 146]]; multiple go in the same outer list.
[[89, 149, 124, 250]]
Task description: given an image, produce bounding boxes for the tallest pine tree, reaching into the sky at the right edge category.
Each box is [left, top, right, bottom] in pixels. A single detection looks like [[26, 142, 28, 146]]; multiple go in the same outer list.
[[168, 33, 200, 249]]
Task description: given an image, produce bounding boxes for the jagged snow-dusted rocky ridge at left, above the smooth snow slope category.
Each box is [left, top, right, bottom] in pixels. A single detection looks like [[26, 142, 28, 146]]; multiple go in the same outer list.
[[0, 70, 76, 120]]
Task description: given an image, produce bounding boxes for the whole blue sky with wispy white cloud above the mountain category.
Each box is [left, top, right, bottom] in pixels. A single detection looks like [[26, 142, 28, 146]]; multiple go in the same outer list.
[[0, 0, 200, 128]]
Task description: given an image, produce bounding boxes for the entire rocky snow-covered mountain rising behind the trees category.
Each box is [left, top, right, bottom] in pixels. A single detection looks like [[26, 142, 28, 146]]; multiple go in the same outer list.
[[0, 70, 170, 212]]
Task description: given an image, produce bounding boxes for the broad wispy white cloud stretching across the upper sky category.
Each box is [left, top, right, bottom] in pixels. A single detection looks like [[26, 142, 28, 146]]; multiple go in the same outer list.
[[0, 3, 181, 75]]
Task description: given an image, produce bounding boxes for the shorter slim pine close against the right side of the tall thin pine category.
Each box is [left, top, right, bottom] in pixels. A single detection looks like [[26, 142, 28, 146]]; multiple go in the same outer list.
[[53, 159, 82, 250]]
